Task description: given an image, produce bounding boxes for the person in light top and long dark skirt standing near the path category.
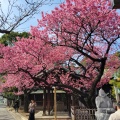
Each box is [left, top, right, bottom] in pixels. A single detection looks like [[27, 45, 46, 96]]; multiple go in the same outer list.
[[28, 100, 36, 120]]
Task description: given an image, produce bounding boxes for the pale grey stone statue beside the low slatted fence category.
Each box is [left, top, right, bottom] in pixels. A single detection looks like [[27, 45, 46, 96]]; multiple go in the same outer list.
[[95, 88, 115, 120]]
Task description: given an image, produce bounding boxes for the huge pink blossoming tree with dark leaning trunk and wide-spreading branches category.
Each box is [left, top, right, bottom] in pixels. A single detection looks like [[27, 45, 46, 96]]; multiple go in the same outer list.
[[0, 0, 120, 107]]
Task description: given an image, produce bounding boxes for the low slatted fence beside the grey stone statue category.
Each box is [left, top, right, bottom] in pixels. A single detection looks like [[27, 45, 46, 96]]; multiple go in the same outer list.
[[74, 107, 96, 120]]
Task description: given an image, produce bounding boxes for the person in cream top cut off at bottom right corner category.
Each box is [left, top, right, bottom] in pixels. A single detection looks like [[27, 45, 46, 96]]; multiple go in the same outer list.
[[108, 101, 120, 120]]
